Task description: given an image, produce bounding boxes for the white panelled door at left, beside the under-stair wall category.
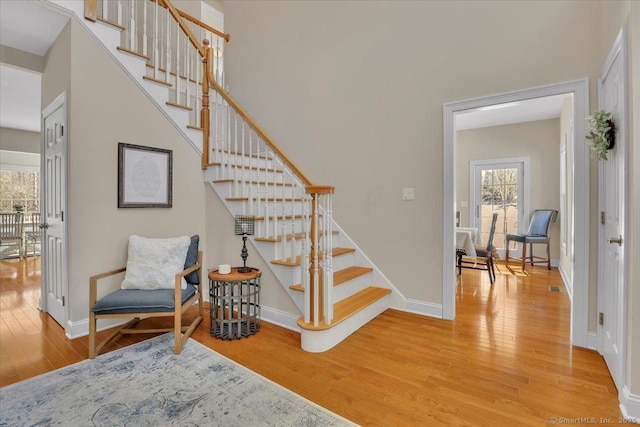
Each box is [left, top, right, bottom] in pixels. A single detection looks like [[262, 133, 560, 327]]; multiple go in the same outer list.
[[40, 93, 68, 328]]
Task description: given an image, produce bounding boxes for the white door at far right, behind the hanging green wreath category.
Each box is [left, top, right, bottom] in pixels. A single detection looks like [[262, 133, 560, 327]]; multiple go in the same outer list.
[[598, 27, 627, 391]]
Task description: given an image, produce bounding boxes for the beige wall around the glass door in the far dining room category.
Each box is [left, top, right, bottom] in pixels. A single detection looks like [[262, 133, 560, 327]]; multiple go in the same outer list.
[[456, 119, 560, 259]]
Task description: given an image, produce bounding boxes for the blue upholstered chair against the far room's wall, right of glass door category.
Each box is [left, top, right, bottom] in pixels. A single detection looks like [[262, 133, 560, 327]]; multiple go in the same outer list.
[[505, 209, 558, 272]]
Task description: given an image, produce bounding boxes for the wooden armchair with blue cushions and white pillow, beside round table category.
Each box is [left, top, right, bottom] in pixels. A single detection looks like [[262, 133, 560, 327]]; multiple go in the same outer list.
[[89, 235, 204, 359]]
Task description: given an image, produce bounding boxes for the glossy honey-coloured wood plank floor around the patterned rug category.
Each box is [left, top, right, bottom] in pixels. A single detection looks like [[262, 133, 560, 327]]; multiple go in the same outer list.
[[0, 258, 620, 426]]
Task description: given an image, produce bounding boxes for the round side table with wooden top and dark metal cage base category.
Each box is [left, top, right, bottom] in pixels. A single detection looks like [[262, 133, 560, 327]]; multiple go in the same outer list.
[[209, 267, 262, 340]]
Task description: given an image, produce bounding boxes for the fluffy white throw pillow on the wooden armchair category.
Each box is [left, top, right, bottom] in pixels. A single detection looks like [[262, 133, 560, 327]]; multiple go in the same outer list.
[[120, 235, 191, 290]]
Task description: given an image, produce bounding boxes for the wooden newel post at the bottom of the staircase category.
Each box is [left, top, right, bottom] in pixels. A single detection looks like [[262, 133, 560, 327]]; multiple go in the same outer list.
[[306, 185, 335, 326]]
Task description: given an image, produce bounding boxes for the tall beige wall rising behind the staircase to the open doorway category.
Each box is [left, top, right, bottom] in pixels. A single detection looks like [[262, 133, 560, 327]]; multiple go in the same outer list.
[[225, 1, 599, 304]]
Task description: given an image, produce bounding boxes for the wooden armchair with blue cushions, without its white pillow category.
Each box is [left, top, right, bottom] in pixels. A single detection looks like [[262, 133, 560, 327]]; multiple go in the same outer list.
[[89, 236, 204, 359]]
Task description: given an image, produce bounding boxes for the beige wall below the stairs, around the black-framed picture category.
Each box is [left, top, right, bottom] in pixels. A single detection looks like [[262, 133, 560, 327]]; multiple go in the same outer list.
[[43, 20, 206, 323]]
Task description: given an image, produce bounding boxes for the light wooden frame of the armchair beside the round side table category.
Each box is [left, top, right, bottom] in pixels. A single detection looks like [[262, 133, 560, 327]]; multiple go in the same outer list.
[[89, 251, 204, 359]]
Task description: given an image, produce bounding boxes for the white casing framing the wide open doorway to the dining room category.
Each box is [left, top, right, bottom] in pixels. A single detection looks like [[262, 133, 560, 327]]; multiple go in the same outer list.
[[442, 78, 590, 347]]
